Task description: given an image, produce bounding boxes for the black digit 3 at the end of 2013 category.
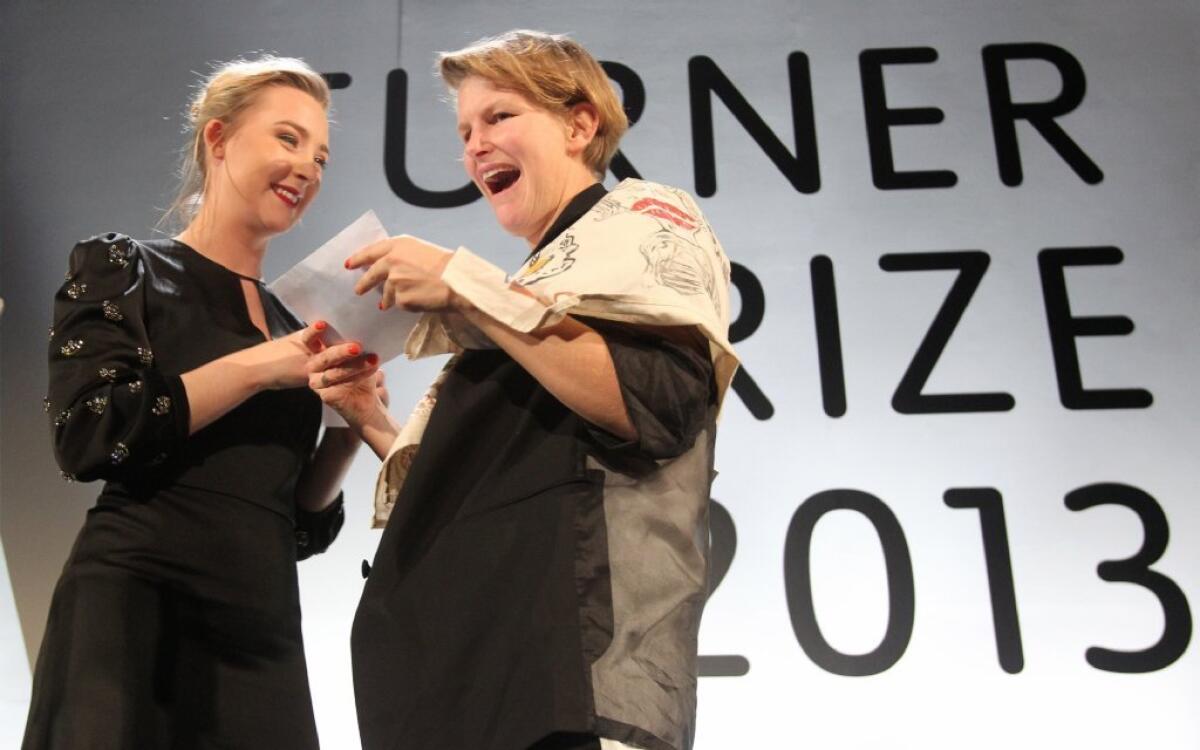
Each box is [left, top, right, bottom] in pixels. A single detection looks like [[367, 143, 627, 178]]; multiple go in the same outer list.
[[1066, 482, 1192, 673]]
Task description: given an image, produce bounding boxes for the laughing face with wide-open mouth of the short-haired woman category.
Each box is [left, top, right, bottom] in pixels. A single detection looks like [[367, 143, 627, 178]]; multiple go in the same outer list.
[[457, 76, 596, 247]]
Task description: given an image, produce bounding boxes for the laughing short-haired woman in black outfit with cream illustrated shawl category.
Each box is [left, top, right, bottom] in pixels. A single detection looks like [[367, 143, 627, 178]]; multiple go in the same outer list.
[[313, 26, 737, 750]]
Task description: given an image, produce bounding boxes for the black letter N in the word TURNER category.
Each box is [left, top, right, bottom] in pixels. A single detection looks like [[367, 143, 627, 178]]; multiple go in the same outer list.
[[688, 52, 821, 198]]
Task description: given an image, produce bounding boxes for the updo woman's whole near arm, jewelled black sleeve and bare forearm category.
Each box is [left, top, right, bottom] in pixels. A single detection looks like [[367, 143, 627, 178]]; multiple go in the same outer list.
[[44, 234, 318, 481]]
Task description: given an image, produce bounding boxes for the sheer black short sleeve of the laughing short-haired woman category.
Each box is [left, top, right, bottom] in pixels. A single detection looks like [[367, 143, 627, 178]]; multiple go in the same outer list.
[[584, 318, 716, 458]]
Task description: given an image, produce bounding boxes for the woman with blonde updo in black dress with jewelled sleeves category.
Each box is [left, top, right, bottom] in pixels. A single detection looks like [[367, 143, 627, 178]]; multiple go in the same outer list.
[[23, 56, 386, 750]]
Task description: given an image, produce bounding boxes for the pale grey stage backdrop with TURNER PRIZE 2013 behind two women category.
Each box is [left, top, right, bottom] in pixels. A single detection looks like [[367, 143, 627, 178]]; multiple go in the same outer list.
[[0, 0, 1200, 750]]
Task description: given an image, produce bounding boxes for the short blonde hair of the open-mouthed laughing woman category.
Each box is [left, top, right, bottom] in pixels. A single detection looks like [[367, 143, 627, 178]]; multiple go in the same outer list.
[[438, 29, 629, 176]]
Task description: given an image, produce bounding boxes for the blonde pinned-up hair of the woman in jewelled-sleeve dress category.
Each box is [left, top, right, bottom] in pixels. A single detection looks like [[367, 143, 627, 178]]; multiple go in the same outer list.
[[160, 55, 330, 227]]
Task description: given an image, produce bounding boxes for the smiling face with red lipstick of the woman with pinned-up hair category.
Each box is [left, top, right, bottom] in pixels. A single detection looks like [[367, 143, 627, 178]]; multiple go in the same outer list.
[[204, 85, 329, 238]]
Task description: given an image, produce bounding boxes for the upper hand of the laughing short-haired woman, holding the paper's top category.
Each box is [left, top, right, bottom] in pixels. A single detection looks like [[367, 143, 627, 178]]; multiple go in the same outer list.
[[346, 234, 463, 312]]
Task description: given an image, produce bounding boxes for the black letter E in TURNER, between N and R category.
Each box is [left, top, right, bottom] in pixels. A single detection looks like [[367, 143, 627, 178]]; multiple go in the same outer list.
[[858, 47, 959, 190]]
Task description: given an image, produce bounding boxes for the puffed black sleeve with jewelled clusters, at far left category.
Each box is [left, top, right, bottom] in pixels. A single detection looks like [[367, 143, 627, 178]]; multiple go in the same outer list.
[[44, 234, 190, 481]]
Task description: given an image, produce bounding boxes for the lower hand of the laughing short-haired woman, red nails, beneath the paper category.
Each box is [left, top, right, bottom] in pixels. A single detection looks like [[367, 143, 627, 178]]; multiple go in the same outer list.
[[307, 342, 388, 431]]
